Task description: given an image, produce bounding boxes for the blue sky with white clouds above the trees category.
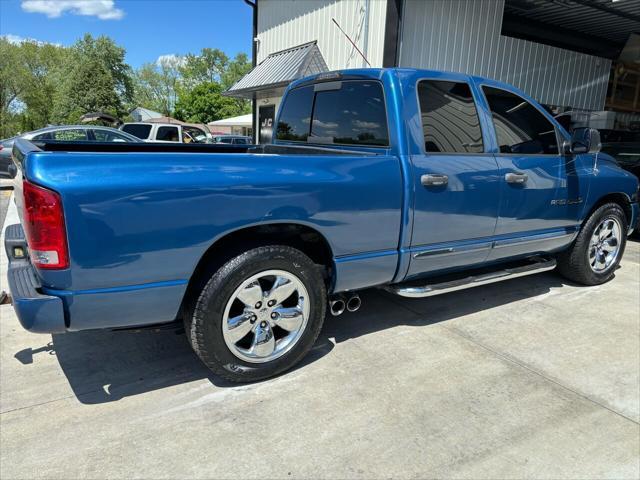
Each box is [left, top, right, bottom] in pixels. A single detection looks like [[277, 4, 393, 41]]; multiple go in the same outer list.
[[0, 0, 252, 68]]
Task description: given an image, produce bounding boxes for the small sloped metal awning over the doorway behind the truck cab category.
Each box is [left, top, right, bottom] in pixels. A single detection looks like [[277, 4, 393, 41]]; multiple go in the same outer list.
[[223, 41, 329, 99]]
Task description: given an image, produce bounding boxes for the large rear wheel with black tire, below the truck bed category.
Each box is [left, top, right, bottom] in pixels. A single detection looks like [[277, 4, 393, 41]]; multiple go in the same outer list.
[[187, 245, 327, 382]]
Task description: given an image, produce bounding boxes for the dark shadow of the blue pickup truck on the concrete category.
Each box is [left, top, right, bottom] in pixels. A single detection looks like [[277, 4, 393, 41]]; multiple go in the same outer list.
[[15, 273, 580, 404]]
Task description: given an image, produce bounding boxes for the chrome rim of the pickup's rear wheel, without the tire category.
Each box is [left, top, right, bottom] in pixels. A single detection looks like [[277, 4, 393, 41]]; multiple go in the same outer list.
[[222, 270, 310, 363]]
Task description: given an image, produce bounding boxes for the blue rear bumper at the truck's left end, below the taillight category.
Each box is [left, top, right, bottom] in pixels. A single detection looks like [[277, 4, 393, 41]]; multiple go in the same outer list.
[[4, 225, 66, 333]]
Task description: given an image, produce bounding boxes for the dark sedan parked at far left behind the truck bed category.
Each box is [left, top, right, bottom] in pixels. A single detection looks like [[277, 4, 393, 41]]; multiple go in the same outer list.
[[0, 125, 140, 178]]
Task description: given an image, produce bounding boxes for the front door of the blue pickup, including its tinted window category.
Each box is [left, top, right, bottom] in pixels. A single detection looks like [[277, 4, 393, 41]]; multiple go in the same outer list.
[[481, 85, 588, 259]]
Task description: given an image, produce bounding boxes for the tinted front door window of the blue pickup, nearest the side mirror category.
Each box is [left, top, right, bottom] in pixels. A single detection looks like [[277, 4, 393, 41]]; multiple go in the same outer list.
[[482, 87, 558, 154]]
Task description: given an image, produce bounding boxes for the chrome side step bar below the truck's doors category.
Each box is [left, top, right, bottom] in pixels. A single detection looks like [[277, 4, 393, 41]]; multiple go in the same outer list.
[[383, 257, 556, 298]]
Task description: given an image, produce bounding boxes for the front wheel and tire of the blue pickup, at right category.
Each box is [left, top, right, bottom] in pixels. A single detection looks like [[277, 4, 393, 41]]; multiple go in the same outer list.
[[558, 203, 628, 285]]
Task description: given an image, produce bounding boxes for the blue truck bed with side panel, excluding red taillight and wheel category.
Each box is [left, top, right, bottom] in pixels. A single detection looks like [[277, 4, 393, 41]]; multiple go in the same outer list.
[[8, 140, 402, 331]]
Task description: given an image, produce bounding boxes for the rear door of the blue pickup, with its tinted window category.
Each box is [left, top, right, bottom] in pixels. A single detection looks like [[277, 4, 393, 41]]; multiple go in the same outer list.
[[408, 80, 500, 277]]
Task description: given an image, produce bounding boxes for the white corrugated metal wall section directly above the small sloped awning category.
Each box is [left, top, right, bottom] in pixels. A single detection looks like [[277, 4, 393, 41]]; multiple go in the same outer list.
[[258, 0, 387, 70]]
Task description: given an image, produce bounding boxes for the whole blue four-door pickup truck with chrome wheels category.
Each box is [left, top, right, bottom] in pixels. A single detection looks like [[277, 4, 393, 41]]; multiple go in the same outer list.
[[5, 69, 638, 381]]
